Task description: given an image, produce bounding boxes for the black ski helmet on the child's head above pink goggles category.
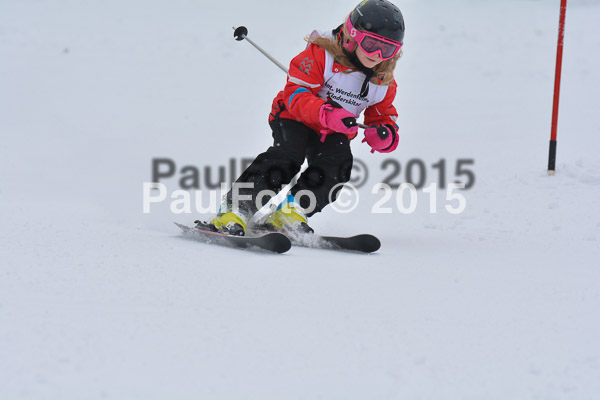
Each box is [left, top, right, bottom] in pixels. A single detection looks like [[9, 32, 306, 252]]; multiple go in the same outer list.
[[350, 0, 404, 43]]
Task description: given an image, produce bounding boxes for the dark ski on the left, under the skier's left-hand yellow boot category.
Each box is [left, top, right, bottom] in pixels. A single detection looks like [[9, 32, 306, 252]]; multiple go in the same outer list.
[[175, 222, 292, 253]]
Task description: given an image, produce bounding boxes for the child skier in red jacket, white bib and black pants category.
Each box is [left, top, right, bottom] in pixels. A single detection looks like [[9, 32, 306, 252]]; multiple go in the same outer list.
[[204, 0, 404, 235]]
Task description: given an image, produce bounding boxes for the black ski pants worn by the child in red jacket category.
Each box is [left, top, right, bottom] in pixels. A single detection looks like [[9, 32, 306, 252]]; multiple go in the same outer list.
[[226, 118, 353, 216]]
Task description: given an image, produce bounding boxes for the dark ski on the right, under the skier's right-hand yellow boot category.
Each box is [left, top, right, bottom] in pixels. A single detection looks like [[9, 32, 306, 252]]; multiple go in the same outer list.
[[249, 227, 381, 253]]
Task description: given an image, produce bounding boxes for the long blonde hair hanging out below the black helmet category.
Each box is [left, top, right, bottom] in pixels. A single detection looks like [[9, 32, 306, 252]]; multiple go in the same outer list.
[[305, 18, 402, 86]]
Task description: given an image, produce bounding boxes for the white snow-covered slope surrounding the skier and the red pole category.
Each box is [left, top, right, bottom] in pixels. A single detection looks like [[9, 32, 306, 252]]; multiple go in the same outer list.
[[0, 0, 600, 399]]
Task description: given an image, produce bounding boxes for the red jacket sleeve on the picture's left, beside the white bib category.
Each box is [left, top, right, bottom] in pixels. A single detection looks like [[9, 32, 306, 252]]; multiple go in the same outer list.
[[283, 44, 325, 125]]
